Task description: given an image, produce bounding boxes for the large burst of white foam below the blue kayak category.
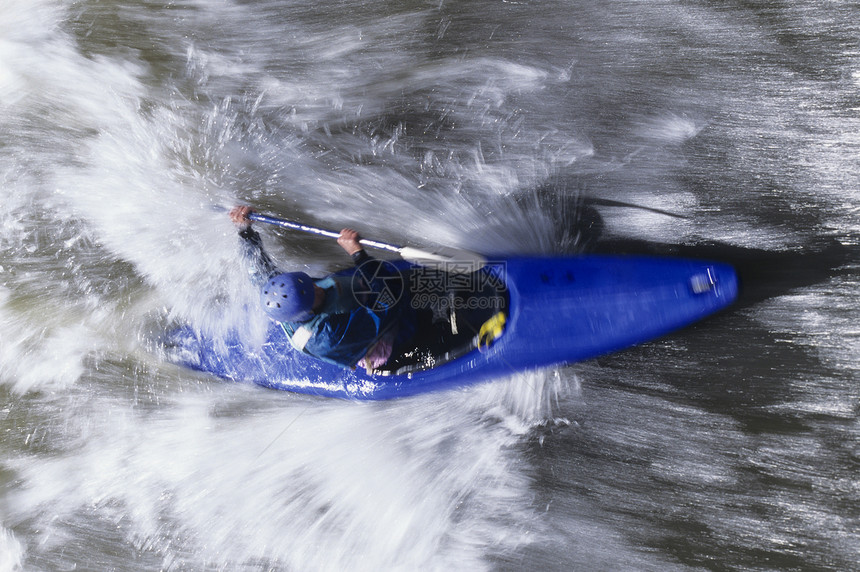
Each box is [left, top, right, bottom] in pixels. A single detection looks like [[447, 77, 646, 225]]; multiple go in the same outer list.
[[8, 376, 576, 570]]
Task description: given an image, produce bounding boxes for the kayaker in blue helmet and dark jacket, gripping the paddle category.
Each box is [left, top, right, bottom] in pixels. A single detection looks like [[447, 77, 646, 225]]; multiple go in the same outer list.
[[230, 206, 414, 371]]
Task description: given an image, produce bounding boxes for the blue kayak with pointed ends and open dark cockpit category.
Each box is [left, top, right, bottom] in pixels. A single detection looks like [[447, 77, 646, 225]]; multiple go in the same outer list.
[[167, 255, 738, 400]]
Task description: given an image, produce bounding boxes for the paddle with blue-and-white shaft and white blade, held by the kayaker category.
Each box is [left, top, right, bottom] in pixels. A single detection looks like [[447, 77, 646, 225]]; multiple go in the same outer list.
[[248, 212, 487, 274]]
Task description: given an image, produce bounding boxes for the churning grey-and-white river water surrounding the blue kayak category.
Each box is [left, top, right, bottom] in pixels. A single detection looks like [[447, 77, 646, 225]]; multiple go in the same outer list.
[[0, 0, 860, 571]]
